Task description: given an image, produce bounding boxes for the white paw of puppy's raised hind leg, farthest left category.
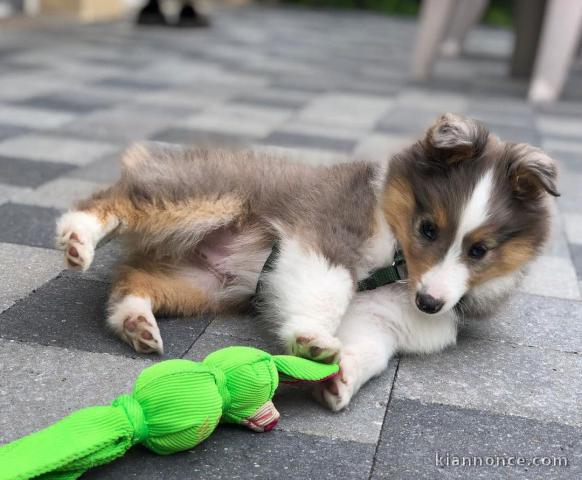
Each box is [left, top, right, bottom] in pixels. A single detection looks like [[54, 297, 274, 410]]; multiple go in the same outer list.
[[56, 212, 102, 271]]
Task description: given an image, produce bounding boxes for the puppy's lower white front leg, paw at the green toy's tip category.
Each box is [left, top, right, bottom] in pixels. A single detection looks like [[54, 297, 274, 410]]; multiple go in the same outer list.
[[314, 289, 401, 411]]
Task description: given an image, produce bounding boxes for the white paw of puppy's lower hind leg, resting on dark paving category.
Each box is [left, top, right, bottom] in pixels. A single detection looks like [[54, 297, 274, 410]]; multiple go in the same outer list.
[[107, 295, 164, 355]]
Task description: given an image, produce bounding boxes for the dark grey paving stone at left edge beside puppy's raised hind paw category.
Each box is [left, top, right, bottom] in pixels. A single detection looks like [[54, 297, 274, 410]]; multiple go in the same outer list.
[[0, 203, 61, 248]]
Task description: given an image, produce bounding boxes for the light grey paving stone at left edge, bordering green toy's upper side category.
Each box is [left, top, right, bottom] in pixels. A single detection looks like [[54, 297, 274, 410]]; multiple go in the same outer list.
[[0, 339, 150, 443]]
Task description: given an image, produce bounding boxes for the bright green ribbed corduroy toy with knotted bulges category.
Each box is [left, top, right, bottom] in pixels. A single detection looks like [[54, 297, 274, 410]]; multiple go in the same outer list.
[[0, 347, 338, 480]]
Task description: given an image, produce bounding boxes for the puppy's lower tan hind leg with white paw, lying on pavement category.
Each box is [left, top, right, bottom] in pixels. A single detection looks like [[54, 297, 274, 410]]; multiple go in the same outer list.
[[107, 262, 221, 354]]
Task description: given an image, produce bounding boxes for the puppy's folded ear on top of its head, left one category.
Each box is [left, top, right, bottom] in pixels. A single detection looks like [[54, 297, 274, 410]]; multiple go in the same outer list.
[[424, 113, 489, 165]]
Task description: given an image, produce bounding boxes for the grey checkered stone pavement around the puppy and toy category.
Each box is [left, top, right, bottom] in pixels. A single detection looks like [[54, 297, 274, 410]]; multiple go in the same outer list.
[[0, 4, 582, 479]]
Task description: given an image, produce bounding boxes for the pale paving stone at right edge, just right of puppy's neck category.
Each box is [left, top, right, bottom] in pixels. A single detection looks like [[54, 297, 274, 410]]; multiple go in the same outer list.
[[519, 255, 580, 300]]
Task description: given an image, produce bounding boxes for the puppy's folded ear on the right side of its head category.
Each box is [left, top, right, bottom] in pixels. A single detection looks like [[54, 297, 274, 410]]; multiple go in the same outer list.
[[507, 143, 560, 197]]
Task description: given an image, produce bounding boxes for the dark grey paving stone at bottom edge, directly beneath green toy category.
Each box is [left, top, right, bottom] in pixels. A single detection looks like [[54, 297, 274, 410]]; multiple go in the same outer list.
[[84, 426, 374, 480]]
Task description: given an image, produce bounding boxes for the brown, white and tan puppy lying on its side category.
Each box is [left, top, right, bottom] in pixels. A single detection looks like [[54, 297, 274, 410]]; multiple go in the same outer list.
[[57, 114, 558, 410]]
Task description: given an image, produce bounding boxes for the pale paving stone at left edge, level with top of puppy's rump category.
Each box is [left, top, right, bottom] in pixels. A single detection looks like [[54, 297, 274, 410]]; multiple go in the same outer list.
[[0, 134, 117, 165]]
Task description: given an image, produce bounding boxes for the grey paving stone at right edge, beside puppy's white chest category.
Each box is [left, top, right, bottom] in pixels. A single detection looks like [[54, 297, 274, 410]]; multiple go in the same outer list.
[[462, 293, 582, 352]]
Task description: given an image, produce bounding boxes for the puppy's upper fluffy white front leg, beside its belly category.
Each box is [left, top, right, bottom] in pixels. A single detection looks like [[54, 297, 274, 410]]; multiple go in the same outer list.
[[261, 237, 354, 362]]
